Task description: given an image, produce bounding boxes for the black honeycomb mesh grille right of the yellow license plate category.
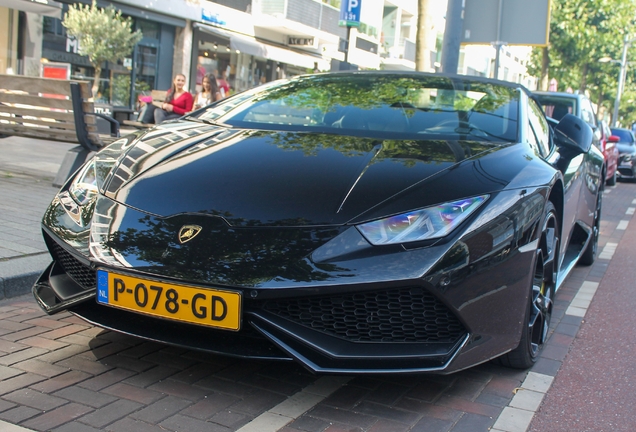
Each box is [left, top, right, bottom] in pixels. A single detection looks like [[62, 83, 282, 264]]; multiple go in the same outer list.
[[263, 287, 466, 343]]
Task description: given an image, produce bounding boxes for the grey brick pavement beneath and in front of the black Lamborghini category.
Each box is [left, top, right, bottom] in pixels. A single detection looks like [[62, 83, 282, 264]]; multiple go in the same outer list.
[[0, 136, 636, 432]]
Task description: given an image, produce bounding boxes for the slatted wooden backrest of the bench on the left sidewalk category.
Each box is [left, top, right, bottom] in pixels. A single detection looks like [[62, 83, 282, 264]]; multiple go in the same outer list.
[[0, 75, 102, 147]]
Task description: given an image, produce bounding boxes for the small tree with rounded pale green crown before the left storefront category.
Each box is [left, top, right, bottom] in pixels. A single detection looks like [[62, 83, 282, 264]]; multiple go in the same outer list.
[[62, 0, 142, 96]]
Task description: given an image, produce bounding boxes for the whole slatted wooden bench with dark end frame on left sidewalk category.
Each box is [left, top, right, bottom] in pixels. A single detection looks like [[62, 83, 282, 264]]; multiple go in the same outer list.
[[0, 74, 119, 185]]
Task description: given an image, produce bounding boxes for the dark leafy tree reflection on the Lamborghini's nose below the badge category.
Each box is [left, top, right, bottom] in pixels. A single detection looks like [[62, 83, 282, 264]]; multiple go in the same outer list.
[[104, 216, 347, 286]]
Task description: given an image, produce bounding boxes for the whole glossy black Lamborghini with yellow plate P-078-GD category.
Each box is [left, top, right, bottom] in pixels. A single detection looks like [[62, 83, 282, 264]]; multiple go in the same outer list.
[[33, 72, 605, 373]]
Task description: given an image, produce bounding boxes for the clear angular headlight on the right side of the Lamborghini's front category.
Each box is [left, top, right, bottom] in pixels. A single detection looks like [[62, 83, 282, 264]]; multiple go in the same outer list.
[[357, 195, 488, 245]]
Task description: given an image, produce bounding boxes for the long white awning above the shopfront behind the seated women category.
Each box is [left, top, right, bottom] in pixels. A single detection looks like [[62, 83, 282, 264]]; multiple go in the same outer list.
[[195, 23, 330, 70]]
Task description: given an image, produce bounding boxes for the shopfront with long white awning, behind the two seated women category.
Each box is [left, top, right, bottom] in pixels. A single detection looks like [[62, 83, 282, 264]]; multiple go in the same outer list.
[[190, 23, 329, 96]]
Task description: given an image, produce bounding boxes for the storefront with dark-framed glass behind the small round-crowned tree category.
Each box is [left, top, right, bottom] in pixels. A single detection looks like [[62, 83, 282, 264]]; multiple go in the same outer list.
[[0, 0, 186, 120]]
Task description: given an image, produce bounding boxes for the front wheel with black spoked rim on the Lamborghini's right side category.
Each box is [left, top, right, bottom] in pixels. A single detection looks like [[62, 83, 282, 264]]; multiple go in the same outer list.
[[500, 201, 560, 369]]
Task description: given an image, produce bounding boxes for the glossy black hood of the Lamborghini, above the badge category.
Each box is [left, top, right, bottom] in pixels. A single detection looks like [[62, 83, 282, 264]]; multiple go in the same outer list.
[[104, 121, 523, 226]]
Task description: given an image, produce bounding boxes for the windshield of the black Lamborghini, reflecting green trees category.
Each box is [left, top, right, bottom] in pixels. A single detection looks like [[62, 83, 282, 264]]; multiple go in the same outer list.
[[193, 73, 519, 142]]
